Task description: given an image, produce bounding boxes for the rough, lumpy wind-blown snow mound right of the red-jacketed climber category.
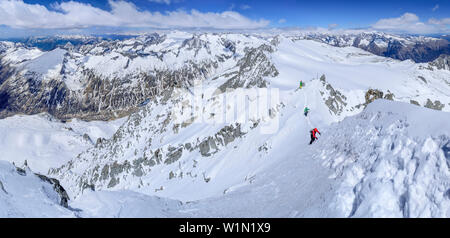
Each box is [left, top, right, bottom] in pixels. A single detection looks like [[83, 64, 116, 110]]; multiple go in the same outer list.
[[320, 100, 450, 217]]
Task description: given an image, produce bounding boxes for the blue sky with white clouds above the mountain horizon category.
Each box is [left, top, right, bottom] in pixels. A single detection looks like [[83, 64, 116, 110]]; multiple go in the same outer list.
[[0, 0, 450, 36]]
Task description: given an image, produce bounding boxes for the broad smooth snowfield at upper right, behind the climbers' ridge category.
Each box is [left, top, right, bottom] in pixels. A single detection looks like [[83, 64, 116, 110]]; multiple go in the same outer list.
[[270, 39, 450, 115]]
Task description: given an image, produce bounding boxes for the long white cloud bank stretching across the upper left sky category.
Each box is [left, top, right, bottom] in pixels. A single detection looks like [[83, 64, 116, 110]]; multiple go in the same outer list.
[[0, 0, 269, 29]]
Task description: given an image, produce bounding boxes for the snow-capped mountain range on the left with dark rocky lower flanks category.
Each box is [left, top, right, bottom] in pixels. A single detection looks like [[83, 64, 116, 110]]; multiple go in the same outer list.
[[0, 32, 274, 120]]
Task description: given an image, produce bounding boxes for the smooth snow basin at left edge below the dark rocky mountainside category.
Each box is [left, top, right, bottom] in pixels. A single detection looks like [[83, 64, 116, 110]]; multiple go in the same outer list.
[[0, 114, 126, 174]]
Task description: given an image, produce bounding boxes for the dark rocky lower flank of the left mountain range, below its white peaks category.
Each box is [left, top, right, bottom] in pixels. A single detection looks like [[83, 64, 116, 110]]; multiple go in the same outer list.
[[0, 58, 214, 120]]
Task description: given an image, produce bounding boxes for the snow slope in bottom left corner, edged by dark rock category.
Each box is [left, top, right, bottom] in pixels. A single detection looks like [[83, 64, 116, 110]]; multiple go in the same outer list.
[[0, 162, 75, 218]]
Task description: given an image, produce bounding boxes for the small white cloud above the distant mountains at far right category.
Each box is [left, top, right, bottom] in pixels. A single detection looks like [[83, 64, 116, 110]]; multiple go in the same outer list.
[[372, 13, 449, 34]]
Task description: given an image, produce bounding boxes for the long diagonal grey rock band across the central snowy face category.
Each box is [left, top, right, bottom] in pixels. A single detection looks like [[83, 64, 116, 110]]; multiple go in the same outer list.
[[49, 121, 245, 195]]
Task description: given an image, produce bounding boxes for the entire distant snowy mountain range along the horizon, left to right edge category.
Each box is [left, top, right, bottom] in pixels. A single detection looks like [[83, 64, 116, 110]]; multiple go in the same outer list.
[[0, 31, 449, 120]]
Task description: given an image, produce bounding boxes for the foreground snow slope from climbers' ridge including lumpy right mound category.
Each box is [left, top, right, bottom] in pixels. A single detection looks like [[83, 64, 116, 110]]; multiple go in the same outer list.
[[60, 98, 450, 217]]
